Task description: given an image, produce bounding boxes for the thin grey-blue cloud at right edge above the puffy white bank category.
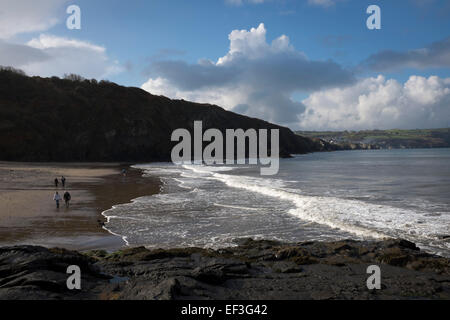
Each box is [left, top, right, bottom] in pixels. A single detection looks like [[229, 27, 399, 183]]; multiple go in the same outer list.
[[363, 37, 450, 72]]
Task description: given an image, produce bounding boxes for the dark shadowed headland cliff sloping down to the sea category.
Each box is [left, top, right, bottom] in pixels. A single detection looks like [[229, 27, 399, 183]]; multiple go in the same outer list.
[[0, 70, 332, 162]]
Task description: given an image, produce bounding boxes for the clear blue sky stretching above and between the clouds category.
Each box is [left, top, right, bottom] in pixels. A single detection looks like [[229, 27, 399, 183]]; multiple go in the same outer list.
[[43, 0, 450, 86]]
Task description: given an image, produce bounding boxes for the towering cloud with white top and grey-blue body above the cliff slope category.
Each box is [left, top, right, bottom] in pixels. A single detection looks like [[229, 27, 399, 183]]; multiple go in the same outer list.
[[142, 24, 354, 125]]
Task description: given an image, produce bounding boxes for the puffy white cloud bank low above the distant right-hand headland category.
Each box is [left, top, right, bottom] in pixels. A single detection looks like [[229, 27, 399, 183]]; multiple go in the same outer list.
[[300, 75, 450, 130]]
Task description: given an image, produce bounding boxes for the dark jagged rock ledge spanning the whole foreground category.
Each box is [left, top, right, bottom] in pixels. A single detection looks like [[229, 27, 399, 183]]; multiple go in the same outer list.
[[0, 239, 450, 300]]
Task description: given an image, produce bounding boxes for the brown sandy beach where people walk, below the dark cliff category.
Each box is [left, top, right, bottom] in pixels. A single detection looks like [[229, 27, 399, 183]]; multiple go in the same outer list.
[[0, 162, 160, 251]]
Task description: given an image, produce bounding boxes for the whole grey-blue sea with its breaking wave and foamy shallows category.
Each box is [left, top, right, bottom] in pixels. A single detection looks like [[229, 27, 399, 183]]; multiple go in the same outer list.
[[103, 149, 450, 257]]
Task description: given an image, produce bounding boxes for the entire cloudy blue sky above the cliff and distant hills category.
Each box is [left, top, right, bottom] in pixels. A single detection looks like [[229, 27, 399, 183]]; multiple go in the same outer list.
[[0, 0, 450, 130]]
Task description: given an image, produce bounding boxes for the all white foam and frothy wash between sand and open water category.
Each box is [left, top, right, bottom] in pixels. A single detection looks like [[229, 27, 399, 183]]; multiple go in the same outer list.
[[104, 164, 450, 253]]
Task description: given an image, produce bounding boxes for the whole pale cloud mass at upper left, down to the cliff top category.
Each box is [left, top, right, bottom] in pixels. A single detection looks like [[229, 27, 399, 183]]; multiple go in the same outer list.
[[0, 0, 116, 78]]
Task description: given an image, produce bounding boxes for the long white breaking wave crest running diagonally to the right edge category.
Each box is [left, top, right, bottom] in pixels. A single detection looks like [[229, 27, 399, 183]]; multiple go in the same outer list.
[[182, 166, 450, 245]]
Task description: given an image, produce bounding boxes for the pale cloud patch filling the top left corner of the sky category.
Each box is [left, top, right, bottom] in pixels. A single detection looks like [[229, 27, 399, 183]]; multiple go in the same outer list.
[[0, 0, 68, 39]]
